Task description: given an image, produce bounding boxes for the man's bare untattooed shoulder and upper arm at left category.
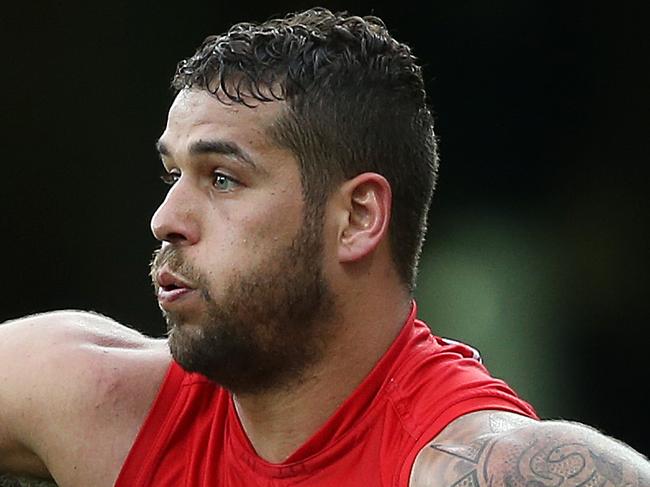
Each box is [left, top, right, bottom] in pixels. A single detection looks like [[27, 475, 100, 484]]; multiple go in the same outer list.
[[0, 311, 170, 485]]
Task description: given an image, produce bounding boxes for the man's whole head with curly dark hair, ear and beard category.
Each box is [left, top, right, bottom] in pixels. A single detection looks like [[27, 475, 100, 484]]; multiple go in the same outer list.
[[152, 9, 436, 393]]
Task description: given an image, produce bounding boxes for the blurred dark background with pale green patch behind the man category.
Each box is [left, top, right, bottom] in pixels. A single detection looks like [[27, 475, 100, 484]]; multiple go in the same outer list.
[[0, 0, 650, 454]]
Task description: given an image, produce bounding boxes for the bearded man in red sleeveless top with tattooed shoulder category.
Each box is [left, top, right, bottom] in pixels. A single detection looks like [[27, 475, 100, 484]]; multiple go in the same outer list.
[[0, 9, 650, 487]]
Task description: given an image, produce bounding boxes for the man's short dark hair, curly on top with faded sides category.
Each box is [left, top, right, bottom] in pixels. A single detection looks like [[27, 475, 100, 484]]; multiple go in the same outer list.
[[172, 8, 438, 292]]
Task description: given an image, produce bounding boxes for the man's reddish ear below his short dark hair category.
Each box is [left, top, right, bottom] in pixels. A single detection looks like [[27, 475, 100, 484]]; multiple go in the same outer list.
[[338, 173, 392, 262]]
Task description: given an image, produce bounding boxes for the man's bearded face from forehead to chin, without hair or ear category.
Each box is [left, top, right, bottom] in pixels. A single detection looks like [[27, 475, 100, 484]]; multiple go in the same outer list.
[[152, 90, 336, 394]]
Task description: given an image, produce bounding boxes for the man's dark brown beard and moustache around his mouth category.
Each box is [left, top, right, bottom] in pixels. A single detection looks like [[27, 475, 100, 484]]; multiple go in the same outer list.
[[151, 220, 336, 394]]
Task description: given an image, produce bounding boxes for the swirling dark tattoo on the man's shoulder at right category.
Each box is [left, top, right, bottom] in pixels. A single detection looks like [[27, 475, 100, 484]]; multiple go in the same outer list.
[[430, 423, 650, 487]]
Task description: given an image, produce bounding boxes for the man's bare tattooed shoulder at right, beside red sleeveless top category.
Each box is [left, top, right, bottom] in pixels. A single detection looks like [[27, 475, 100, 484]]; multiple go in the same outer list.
[[410, 411, 650, 487]]
